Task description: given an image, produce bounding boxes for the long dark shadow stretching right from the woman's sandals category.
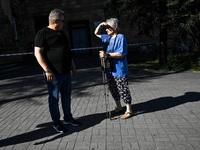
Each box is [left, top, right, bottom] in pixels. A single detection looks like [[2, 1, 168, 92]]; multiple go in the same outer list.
[[132, 92, 200, 115]]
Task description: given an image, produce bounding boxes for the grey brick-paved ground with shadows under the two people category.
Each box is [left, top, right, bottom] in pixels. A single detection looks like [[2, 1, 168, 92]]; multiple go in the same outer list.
[[0, 57, 200, 150]]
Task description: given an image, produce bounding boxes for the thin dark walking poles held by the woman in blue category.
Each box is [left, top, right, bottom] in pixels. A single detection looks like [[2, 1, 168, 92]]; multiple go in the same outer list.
[[101, 58, 111, 120]]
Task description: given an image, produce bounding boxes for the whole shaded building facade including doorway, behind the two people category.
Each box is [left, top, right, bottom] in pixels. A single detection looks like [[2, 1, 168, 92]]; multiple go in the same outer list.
[[0, 0, 158, 54]]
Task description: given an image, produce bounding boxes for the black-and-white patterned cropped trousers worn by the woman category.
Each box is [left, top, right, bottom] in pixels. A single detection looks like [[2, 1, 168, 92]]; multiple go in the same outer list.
[[107, 75, 132, 104]]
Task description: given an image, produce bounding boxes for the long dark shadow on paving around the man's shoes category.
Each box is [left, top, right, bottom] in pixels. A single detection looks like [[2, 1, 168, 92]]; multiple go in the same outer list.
[[0, 113, 106, 147]]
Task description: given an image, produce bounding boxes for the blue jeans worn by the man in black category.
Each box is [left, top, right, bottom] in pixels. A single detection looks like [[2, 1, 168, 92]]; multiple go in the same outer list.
[[44, 73, 73, 122]]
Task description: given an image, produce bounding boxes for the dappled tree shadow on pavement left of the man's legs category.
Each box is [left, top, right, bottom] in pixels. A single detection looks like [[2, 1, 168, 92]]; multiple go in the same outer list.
[[0, 75, 48, 107]]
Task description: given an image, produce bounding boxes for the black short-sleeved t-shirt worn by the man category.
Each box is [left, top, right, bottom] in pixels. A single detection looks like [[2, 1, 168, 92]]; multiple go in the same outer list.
[[35, 27, 72, 74]]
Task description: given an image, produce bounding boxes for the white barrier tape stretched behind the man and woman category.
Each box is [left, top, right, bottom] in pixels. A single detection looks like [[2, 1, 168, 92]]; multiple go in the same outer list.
[[0, 42, 155, 57]]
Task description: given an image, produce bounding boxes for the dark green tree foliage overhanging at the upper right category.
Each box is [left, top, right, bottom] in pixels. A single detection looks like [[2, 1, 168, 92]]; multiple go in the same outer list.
[[106, 0, 200, 49]]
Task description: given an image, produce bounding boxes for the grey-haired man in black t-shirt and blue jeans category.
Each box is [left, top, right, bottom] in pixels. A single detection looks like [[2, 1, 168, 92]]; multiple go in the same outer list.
[[34, 9, 80, 132]]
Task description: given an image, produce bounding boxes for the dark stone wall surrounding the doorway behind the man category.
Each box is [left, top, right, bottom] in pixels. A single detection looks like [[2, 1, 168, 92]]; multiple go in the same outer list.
[[0, 0, 157, 55]]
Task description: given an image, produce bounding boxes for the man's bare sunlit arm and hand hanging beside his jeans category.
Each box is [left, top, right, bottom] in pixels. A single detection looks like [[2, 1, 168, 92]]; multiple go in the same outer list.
[[34, 47, 54, 82]]
